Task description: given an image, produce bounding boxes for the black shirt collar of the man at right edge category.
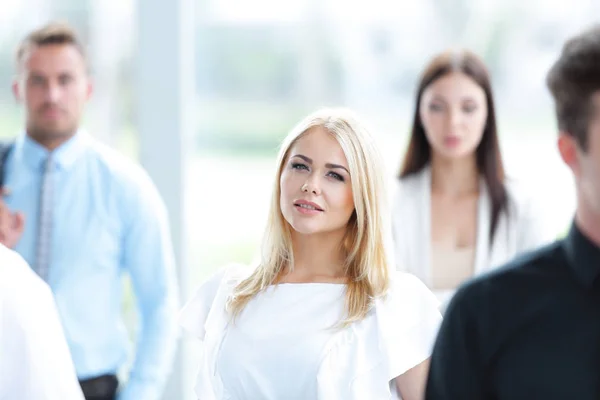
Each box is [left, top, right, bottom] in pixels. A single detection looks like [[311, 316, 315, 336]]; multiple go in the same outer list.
[[563, 222, 600, 288]]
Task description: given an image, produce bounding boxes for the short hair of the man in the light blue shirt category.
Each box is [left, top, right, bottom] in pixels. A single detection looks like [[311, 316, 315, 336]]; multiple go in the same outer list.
[[15, 22, 87, 71]]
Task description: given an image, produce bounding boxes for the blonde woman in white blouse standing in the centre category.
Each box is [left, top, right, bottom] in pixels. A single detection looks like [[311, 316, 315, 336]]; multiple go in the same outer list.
[[180, 109, 441, 400]]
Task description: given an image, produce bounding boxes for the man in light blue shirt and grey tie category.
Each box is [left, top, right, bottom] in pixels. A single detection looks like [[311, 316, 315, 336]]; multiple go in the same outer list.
[[0, 24, 178, 400]]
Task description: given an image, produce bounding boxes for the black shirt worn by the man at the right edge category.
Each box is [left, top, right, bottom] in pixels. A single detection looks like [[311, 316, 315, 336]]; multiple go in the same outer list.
[[426, 224, 600, 400]]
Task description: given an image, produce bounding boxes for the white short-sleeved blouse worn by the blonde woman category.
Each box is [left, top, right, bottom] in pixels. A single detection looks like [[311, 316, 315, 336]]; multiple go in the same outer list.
[[180, 265, 441, 400]]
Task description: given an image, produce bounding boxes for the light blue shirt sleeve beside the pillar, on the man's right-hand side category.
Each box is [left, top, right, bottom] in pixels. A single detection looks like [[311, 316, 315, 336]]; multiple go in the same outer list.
[[119, 172, 178, 400]]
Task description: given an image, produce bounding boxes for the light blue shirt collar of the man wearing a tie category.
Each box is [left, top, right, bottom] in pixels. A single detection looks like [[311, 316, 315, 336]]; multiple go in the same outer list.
[[15, 131, 88, 170]]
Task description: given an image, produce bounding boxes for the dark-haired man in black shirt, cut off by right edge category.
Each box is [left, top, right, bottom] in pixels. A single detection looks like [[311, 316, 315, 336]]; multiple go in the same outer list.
[[426, 25, 600, 400]]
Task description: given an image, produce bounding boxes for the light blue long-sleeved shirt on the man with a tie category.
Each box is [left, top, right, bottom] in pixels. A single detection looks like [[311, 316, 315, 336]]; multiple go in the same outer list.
[[5, 132, 178, 400]]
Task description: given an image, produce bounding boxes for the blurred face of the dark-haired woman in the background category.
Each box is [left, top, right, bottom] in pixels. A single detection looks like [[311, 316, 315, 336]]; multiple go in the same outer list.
[[419, 72, 488, 159]]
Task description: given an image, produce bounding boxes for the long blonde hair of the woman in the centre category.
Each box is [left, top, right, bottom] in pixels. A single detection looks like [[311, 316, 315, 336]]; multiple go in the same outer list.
[[227, 108, 391, 326]]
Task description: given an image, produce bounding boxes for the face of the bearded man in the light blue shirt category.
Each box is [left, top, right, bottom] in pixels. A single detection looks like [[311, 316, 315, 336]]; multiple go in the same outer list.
[[13, 44, 92, 144]]
